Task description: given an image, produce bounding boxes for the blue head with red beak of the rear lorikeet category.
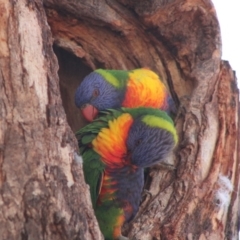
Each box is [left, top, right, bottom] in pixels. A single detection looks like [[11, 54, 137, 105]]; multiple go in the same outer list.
[[75, 71, 124, 121]]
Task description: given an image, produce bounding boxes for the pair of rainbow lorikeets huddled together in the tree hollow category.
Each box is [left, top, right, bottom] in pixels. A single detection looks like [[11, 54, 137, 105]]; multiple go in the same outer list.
[[75, 69, 178, 240]]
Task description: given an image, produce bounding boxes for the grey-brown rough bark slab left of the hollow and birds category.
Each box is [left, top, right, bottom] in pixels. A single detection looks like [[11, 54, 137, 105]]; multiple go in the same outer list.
[[0, 0, 101, 240]]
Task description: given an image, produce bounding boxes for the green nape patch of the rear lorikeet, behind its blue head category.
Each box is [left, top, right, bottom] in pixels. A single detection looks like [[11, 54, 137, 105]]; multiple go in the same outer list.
[[95, 69, 129, 89]]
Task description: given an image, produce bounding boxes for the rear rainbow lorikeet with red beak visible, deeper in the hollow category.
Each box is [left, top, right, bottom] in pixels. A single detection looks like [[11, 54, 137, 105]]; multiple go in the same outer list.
[[75, 68, 176, 122]]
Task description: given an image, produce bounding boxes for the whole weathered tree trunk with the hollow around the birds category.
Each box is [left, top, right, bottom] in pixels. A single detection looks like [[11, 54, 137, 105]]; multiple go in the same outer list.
[[0, 0, 239, 240]]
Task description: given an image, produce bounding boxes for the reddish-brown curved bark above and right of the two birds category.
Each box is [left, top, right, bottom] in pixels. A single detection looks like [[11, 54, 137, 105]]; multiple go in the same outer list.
[[44, 0, 239, 240]]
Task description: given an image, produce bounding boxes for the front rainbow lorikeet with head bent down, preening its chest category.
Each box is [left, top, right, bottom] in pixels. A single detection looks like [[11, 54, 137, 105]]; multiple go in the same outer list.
[[76, 108, 178, 240]]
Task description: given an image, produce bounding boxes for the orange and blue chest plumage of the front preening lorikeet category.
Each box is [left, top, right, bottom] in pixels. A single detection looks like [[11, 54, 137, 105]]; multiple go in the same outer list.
[[92, 113, 143, 220]]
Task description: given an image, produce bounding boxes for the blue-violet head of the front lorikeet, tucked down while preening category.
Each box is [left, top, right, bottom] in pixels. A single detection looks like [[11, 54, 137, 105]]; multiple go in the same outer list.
[[127, 115, 177, 168]]
